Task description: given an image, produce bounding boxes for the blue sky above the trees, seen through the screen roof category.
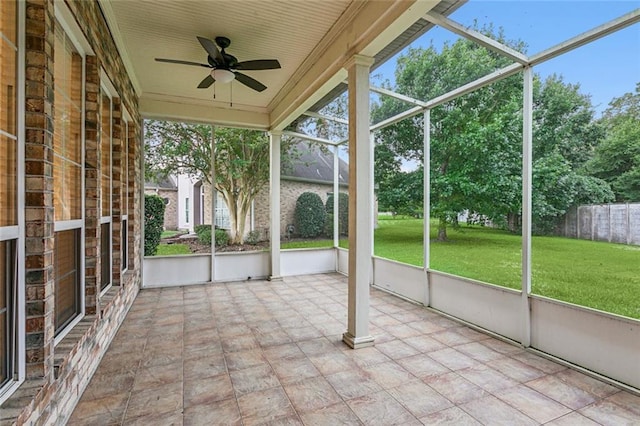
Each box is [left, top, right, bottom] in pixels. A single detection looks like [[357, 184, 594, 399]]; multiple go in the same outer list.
[[373, 0, 640, 115]]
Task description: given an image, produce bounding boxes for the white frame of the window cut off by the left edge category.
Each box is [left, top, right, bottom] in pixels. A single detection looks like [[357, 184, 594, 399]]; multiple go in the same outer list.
[[0, 1, 26, 404]]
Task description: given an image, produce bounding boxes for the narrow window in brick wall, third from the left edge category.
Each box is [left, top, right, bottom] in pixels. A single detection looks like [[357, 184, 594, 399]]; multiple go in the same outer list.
[[100, 90, 112, 290]]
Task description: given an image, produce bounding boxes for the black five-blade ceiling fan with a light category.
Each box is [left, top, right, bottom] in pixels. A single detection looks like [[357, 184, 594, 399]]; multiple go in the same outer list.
[[156, 36, 280, 92]]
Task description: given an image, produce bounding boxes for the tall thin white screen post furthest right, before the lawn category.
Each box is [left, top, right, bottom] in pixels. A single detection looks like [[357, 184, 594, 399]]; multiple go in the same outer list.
[[521, 67, 533, 347]]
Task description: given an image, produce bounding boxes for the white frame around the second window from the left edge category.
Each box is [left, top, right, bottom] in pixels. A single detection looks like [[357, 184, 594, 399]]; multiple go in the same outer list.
[[53, 1, 93, 346]]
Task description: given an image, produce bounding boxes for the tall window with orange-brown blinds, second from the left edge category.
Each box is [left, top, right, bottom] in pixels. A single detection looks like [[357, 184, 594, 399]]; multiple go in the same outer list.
[[53, 21, 84, 335]]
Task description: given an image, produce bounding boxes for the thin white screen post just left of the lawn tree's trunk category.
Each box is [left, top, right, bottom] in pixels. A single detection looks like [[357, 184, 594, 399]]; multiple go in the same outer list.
[[422, 109, 431, 306]]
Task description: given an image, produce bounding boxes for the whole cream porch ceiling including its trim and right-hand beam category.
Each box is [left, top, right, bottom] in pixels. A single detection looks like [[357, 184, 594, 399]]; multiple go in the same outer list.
[[99, 0, 448, 129]]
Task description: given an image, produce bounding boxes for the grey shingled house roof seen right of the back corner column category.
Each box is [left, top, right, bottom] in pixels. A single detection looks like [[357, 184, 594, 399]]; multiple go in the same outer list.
[[282, 141, 349, 185]]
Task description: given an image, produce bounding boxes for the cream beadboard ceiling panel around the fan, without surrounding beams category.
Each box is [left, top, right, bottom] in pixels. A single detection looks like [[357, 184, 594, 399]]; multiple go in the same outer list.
[[103, 0, 351, 111]]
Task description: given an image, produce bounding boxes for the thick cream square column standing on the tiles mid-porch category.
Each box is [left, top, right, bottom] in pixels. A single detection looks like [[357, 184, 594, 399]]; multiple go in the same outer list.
[[342, 55, 374, 349]]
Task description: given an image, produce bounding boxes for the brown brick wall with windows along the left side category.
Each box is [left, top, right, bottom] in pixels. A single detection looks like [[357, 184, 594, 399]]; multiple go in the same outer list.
[[0, 0, 142, 425]]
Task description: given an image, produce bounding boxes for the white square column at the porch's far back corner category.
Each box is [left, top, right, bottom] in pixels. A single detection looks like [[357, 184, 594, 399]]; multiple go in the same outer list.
[[269, 132, 282, 281]]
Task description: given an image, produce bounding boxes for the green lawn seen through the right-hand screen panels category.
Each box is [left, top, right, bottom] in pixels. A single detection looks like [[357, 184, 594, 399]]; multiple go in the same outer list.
[[374, 218, 640, 318]]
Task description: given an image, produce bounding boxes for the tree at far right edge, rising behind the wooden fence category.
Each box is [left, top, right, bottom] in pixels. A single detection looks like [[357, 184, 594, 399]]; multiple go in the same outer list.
[[585, 83, 640, 202]]
